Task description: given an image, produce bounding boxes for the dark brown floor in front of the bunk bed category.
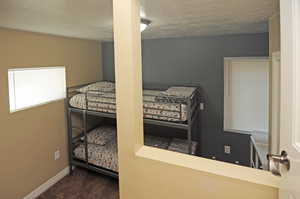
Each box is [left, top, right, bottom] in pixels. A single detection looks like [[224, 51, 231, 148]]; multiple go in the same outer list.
[[37, 168, 119, 199]]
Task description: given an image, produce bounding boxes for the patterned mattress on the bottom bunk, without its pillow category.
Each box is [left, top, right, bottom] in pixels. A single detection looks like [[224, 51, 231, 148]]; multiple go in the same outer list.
[[73, 127, 197, 172]]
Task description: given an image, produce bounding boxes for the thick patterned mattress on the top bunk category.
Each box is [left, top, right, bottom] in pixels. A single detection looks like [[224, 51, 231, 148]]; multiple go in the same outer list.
[[70, 90, 187, 122]]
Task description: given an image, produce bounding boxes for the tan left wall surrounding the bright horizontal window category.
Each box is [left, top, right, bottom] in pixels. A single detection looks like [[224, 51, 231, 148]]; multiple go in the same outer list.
[[0, 28, 102, 199]]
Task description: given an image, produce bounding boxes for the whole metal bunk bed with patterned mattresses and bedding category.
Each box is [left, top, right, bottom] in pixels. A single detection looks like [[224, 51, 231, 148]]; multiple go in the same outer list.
[[66, 81, 200, 178]]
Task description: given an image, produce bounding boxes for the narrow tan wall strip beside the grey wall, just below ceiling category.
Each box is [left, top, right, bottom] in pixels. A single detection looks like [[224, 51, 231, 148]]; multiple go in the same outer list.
[[269, 14, 280, 56]]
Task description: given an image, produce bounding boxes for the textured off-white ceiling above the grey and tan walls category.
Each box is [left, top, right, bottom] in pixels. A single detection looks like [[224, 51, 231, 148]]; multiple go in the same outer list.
[[0, 0, 277, 40]]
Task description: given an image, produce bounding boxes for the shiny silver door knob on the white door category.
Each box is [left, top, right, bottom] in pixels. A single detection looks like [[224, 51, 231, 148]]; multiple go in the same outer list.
[[267, 151, 290, 176]]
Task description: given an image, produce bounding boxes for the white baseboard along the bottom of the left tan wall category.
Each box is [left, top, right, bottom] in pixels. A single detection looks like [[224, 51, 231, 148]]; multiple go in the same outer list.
[[23, 167, 70, 199]]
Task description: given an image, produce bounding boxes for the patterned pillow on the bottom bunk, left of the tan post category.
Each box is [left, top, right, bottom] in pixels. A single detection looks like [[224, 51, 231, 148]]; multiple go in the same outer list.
[[87, 126, 117, 146]]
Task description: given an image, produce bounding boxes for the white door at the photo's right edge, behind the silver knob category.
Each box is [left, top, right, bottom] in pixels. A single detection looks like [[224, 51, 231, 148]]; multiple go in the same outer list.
[[272, 0, 300, 199]]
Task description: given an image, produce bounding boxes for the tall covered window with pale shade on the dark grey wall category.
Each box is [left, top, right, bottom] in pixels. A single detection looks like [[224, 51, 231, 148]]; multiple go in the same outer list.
[[224, 57, 269, 133]]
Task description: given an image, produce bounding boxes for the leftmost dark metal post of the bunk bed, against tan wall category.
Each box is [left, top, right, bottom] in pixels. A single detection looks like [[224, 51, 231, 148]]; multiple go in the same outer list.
[[65, 88, 73, 175]]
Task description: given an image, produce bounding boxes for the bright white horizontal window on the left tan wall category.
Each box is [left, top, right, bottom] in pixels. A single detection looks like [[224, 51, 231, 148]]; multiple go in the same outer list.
[[8, 67, 66, 112]]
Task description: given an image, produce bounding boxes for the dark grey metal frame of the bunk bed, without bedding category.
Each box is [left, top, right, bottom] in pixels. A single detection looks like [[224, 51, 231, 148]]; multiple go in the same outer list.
[[66, 83, 200, 178]]
